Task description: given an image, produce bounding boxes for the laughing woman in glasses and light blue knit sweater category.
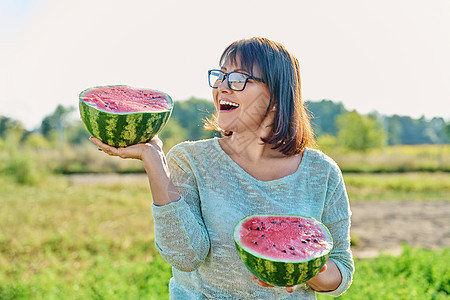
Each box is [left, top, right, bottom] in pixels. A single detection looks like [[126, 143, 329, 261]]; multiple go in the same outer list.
[[91, 38, 354, 299]]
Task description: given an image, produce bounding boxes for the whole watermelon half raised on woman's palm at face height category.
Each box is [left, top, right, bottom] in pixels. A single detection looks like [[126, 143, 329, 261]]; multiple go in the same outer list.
[[79, 85, 173, 147]]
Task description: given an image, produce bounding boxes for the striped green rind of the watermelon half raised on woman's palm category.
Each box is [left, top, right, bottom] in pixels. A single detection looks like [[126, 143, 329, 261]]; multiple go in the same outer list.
[[79, 85, 173, 147]]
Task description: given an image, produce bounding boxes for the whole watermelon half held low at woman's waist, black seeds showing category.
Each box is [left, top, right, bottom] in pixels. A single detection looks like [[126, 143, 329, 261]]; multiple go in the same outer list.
[[234, 215, 333, 286]]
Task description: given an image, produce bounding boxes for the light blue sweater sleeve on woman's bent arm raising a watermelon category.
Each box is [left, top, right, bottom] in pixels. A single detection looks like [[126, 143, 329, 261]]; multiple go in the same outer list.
[[152, 145, 210, 272]]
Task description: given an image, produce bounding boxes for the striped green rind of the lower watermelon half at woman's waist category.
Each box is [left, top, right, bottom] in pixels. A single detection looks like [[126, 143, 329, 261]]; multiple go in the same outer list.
[[233, 214, 333, 286]]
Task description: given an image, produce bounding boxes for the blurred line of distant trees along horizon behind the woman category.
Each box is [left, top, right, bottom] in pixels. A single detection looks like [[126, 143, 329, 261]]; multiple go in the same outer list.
[[0, 98, 450, 151]]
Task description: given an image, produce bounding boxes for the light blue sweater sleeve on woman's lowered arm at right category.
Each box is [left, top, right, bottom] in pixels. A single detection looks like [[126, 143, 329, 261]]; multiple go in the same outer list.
[[322, 170, 354, 297]]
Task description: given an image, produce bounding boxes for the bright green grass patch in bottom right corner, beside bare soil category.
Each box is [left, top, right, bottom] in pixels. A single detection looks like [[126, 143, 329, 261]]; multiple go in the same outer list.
[[317, 246, 450, 300]]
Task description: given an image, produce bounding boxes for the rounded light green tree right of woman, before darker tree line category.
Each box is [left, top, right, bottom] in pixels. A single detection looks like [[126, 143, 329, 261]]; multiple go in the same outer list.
[[336, 110, 385, 151]]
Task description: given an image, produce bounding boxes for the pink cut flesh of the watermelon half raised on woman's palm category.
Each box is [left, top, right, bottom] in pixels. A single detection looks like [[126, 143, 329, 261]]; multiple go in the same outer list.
[[82, 86, 171, 113]]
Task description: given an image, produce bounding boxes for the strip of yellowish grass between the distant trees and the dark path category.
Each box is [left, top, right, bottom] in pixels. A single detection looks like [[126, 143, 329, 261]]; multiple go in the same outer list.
[[0, 141, 450, 177]]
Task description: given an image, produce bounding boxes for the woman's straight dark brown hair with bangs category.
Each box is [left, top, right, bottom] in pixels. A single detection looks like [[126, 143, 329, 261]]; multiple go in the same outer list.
[[205, 37, 316, 155]]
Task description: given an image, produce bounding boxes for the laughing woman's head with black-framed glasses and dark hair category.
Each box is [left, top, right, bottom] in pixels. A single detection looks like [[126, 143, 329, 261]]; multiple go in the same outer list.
[[205, 39, 315, 154]]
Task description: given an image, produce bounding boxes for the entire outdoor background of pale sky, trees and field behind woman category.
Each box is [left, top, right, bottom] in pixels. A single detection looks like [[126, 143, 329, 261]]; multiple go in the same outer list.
[[0, 0, 450, 299]]
